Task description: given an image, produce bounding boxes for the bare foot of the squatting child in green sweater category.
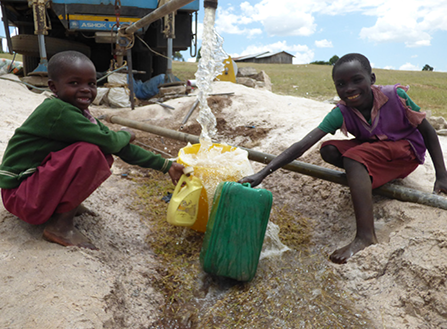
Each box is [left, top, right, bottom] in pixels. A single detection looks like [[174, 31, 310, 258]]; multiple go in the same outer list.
[[43, 207, 98, 250]]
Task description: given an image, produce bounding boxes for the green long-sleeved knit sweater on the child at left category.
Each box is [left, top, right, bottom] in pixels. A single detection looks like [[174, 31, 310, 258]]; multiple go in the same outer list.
[[0, 98, 172, 189]]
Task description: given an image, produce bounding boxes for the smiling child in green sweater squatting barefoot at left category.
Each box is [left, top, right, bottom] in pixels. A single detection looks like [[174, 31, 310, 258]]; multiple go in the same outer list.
[[0, 51, 183, 249]]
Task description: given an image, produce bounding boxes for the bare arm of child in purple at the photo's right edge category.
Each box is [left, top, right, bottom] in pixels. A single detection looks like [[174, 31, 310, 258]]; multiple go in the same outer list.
[[418, 119, 447, 193]]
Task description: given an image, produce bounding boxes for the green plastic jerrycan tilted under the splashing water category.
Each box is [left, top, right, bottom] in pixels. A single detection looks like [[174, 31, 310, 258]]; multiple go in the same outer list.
[[200, 182, 273, 281]]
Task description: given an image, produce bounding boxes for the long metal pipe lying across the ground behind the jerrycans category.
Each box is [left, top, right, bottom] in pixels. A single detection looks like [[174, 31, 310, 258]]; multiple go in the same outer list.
[[105, 115, 447, 209]]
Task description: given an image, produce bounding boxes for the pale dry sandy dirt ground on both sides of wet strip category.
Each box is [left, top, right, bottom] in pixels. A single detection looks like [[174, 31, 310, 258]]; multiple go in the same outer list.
[[0, 76, 447, 329]]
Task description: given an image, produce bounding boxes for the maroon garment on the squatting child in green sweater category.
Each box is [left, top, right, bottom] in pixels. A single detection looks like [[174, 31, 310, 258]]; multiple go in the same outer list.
[[2, 142, 113, 225]]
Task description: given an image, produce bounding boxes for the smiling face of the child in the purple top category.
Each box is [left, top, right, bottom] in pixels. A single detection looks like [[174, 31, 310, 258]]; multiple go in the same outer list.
[[334, 60, 376, 111]]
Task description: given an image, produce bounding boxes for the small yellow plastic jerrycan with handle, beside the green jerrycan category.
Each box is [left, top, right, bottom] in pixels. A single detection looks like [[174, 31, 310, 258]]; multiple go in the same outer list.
[[167, 167, 202, 227]]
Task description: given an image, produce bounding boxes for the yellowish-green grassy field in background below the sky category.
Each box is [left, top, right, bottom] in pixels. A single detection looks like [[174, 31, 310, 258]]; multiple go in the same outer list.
[[172, 62, 447, 117]]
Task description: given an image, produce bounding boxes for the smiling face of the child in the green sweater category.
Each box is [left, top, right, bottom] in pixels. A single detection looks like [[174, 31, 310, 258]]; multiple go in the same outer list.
[[48, 59, 97, 110]]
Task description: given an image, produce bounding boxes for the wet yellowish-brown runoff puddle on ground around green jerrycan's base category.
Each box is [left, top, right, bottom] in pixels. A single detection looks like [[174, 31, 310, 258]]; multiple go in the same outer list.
[[142, 191, 374, 329]]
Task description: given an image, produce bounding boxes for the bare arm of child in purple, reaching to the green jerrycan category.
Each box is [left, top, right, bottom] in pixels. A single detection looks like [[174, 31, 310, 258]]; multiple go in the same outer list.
[[239, 128, 327, 187]]
